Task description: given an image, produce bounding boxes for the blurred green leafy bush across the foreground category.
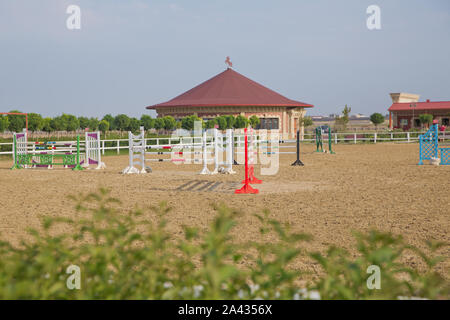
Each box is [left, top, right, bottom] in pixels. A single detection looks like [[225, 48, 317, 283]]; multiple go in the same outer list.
[[0, 190, 448, 299]]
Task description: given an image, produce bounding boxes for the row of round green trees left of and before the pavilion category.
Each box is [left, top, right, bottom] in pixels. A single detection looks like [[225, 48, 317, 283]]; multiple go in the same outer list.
[[0, 110, 260, 133]]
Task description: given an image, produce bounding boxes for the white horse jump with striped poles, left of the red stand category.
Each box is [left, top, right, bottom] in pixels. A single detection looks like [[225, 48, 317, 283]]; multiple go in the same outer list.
[[122, 127, 234, 174]]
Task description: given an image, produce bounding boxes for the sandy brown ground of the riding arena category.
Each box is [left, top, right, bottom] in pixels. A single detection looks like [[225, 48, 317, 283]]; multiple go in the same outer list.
[[0, 144, 450, 277]]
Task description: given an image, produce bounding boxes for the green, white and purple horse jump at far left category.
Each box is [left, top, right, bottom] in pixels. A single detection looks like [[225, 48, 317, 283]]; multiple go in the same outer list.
[[11, 130, 105, 170]]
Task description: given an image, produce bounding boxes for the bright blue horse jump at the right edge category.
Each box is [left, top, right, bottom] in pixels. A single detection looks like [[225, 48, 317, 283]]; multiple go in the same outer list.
[[418, 123, 450, 165]]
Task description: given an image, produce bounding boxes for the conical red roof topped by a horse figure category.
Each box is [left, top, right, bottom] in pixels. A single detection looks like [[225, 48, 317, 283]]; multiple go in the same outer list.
[[147, 68, 313, 109]]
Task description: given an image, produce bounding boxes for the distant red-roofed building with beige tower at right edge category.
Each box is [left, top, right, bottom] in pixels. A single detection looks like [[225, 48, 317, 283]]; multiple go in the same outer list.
[[388, 93, 450, 130]]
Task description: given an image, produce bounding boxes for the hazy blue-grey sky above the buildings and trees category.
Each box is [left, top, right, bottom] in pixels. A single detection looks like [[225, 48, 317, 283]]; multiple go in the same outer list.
[[0, 0, 450, 117]]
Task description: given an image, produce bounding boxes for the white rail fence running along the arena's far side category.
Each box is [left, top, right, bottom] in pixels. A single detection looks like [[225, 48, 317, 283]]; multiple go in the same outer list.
[[0, 132, 450, 155]]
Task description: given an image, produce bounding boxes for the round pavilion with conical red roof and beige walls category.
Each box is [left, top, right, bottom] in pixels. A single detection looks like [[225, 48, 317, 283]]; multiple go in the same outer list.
[[147, 68, 313, 137]]
